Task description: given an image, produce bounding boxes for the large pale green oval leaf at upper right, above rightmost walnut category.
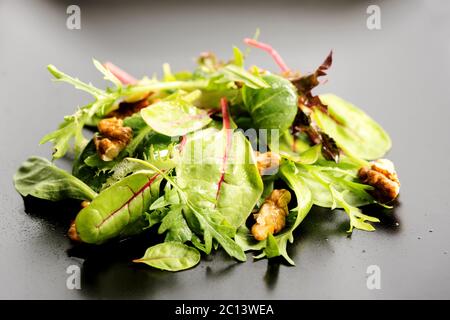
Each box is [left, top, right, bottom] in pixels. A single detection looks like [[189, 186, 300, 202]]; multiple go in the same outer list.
[[311, 94, 391, 160]]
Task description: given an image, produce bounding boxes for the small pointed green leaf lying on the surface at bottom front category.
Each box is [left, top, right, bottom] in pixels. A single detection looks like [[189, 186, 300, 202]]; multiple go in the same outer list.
[[133, 242, 200, 271]]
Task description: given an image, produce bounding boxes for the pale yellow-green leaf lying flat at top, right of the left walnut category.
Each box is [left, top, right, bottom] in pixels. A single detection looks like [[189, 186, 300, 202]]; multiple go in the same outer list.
[[141, 94, 211, 137]]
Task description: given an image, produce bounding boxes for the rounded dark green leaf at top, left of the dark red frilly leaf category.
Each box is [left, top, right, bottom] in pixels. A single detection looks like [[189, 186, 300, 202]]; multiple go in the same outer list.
[[242, 74, 298, 130]]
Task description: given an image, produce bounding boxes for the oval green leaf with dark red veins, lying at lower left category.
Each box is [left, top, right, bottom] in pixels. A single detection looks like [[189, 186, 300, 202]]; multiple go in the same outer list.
[[75, 171, 161, 244]]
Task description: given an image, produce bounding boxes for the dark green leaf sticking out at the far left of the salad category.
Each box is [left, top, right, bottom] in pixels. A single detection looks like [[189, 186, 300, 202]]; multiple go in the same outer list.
[[13, 156, 97, 201]]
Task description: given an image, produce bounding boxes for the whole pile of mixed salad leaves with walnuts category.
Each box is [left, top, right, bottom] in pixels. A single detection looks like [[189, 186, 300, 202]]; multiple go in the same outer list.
[[14, 37, 400, 271]]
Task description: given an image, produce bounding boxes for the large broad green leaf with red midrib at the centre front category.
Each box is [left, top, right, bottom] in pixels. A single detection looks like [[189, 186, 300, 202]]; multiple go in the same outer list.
[[176, 128, 263, 228]]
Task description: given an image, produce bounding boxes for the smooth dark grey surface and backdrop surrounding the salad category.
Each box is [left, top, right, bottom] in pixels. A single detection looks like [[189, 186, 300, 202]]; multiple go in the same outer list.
[[0, 0, 450, 299]]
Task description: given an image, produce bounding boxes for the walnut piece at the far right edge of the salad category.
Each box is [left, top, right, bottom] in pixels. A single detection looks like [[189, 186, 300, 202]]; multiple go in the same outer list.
[[358, 159, 400, 203]]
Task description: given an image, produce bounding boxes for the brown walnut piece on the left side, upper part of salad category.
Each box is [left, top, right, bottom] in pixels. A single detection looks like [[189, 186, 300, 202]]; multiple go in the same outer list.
[[94, 117, 133, 161]]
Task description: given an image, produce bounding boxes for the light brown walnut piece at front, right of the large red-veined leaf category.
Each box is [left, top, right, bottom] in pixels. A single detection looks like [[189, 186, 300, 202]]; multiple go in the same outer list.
[[252, 189, 291, 241]]
